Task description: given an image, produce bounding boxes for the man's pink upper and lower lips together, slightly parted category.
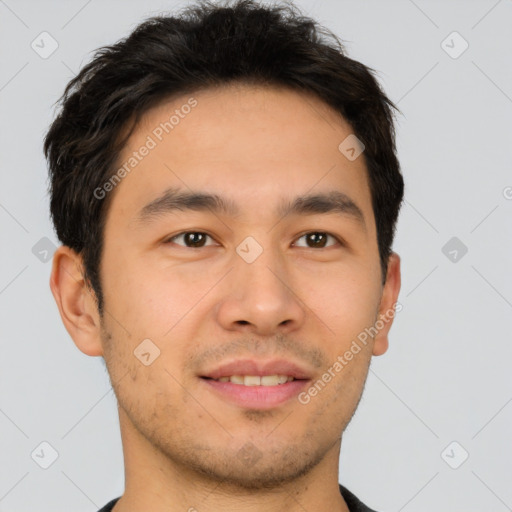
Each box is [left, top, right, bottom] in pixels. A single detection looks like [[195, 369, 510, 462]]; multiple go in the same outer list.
[[200, 359, 311, 410]]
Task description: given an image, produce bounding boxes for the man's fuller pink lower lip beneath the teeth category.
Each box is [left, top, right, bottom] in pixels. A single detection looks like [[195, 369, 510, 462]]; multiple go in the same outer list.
[[201, 378, 309, 409]]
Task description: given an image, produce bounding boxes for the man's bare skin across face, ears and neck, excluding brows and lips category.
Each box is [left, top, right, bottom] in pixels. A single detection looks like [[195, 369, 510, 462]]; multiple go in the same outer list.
[[50, 85, 400, 512]]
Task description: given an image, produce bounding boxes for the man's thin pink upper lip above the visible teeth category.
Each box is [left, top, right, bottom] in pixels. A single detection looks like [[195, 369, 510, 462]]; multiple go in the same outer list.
[[201, 359, 311, 379]]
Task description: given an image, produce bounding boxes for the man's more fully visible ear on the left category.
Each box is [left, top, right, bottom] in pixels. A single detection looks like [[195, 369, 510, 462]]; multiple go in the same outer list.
[[50, 245, 103, 356]]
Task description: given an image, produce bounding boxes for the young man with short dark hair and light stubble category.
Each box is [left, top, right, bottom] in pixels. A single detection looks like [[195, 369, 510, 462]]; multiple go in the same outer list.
[[45, 0, 403, 512]]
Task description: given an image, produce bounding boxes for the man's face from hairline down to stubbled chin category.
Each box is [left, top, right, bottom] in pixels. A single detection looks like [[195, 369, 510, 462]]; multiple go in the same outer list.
[[67, 86, 398, 488]]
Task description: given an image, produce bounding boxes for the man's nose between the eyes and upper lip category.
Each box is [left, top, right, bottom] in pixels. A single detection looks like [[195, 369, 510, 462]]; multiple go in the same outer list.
[[217, 244, 305, 336]]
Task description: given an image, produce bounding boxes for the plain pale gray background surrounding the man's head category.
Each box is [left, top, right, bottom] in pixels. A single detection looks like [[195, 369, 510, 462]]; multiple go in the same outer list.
[[0, 0, 512, 512]]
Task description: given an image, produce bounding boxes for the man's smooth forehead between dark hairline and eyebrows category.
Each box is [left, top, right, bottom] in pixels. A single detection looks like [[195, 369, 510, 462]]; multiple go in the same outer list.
[[106, 85, 372, 230]]
